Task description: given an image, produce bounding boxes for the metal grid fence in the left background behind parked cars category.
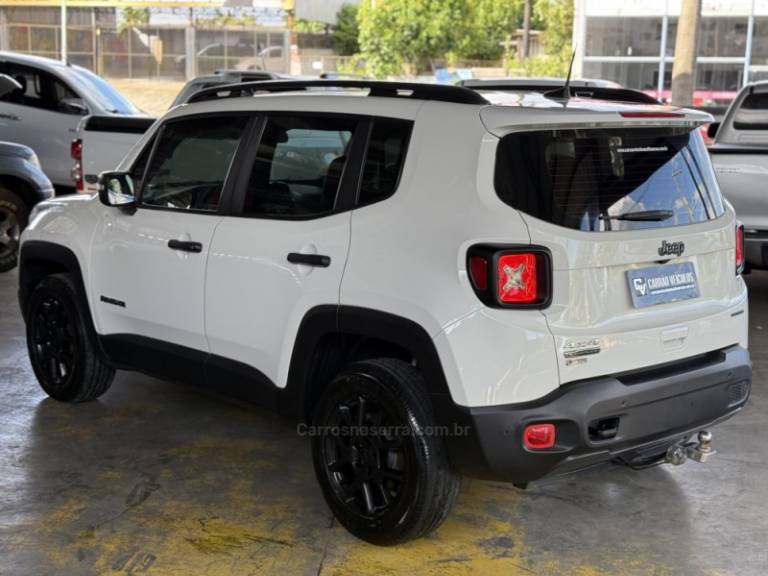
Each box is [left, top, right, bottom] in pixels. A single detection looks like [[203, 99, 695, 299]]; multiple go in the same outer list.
[[0, 9, 290, 79]]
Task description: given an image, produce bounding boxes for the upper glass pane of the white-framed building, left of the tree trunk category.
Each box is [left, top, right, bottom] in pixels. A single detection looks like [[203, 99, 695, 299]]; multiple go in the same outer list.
[[585, 17, 662, 56]]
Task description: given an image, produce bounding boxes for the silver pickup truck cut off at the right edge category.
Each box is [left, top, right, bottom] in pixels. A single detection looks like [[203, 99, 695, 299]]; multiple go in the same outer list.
[[708, 81, 768, 268]]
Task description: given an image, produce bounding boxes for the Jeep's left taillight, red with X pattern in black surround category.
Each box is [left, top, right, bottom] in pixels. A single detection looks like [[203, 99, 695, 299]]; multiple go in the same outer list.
[[467, 244, 552, 308]]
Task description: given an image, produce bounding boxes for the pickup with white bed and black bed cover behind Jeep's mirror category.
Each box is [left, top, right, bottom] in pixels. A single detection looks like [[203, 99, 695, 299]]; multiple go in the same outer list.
[[71, 70, 300, 193]]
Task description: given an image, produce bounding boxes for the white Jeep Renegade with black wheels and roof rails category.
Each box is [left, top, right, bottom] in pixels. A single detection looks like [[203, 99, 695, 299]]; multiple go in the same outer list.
[[19, 81, 751, 544]]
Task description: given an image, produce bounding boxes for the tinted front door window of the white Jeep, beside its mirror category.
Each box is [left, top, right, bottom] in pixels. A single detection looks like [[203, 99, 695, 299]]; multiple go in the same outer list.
[[141, 116, 248, 212]]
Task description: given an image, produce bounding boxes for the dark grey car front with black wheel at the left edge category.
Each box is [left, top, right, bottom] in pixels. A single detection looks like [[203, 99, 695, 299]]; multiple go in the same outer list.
[[0, 74, 53, 272]]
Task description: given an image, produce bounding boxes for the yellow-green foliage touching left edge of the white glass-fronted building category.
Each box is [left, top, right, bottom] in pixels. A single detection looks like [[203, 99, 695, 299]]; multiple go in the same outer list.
[[525, 0, 573, 76]]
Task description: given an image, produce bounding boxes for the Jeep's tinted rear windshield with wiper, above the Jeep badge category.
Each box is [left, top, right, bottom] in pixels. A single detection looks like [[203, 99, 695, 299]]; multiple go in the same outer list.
[[494, 128, 725, 232]]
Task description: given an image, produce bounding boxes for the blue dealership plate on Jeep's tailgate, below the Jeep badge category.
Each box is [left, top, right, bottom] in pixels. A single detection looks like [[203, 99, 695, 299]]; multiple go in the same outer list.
[[627, 262, 699, 308]]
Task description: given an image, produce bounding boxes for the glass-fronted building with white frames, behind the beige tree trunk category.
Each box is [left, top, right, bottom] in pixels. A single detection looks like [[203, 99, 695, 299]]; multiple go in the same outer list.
[[574, 0, 768, 104]]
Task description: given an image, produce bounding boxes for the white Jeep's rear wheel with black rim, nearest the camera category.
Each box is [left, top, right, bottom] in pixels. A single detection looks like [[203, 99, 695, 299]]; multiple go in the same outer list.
[[310, 358, 461, 546]]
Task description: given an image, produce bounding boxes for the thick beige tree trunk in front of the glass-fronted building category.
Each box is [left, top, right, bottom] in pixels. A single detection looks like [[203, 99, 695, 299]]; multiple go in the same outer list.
[[672, 0, 701, 106]]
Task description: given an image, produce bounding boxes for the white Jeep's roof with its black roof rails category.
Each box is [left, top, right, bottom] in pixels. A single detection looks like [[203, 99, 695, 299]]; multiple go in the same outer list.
[[171, 80, 712, 127]]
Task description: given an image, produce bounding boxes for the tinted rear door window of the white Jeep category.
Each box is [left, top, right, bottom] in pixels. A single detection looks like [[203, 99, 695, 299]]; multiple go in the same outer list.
[[243, 116, 357, 217]]
